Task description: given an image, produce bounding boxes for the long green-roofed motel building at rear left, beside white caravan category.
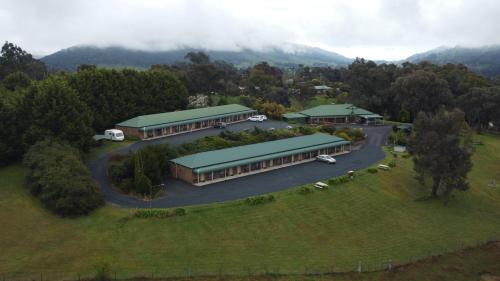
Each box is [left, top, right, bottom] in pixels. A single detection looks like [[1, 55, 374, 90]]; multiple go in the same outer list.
[[115, 104, 257, 140]]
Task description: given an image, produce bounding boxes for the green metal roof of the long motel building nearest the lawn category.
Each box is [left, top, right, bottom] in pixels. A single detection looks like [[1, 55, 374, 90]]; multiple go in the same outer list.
[[172, 133, 350, 173]]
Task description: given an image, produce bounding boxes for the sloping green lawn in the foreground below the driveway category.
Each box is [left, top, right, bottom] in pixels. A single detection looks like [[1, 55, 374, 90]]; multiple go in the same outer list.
[[0, 133, 500, 279]]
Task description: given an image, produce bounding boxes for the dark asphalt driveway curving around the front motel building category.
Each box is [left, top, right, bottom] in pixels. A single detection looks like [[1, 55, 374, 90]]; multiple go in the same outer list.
[[90, 121, 391, 208]]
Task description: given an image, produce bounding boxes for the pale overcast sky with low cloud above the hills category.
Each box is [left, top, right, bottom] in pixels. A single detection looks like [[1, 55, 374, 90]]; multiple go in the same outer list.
[[0, 0, 500, 60]]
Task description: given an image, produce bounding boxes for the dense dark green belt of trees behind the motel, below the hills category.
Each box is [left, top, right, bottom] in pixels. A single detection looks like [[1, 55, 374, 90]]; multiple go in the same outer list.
[[0, 42, 500, 215]]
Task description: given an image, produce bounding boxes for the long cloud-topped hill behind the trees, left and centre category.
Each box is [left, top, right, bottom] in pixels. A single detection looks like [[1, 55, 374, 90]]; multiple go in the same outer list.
[[41, 45, 352, 71]]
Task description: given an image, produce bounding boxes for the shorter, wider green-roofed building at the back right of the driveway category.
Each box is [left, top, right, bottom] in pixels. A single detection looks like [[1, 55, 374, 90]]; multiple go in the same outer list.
[[283, 104, 383, 125]]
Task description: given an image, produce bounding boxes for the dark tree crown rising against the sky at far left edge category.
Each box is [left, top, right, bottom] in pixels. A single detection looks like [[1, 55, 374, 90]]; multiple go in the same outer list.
[[0, 42, 47, 80]]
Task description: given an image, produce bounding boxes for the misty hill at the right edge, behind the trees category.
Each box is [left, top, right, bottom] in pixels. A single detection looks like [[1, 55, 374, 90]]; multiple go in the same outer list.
[[405, 46, 500, 77]]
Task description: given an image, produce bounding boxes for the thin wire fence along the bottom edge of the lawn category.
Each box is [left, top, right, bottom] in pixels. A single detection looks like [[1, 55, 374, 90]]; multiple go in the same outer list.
[[0, 236, 500, 281]]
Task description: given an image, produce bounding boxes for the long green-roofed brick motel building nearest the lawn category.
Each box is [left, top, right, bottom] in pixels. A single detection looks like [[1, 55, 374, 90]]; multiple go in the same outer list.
[[169, 133, 351, 186]]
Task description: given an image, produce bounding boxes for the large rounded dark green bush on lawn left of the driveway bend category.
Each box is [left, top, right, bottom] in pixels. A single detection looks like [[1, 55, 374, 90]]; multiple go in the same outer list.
[[24, 141, 104, 217]]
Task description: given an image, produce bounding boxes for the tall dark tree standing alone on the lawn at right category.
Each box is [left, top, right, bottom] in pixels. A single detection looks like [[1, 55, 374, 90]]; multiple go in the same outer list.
[[408, 109, 473, 198]]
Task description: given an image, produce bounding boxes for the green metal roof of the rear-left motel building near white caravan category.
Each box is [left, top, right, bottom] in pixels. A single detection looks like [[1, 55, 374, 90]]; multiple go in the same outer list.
[[117, 104, 256, 128]]
